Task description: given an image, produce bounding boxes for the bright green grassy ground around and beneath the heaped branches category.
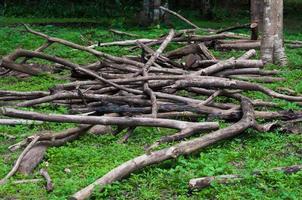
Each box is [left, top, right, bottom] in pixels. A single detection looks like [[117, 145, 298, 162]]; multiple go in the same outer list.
[[0, 17, 302, 199]]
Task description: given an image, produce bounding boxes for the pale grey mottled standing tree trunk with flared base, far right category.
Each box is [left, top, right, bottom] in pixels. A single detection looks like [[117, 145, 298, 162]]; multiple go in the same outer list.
[[261, 0, 287, 66]]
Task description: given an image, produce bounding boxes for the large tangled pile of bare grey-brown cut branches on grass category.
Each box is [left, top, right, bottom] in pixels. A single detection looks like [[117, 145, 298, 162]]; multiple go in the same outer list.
[[0, 23, 302, 199]]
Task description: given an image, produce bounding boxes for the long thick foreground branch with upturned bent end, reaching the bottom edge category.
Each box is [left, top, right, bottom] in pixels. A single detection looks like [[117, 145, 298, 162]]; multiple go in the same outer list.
[[70, 98, 255, 200]]
